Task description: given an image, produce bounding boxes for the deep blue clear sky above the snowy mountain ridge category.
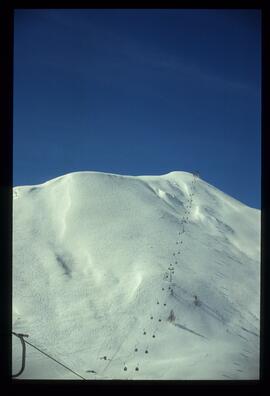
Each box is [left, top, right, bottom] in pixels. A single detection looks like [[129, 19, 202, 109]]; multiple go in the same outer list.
[[14, 10, 261, 208]]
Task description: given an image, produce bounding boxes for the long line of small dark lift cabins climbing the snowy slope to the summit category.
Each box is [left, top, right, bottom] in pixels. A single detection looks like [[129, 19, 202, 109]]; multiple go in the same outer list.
[[94, 174, 198, 373]]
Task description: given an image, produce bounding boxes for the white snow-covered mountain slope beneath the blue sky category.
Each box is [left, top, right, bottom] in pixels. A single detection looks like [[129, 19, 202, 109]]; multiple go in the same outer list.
[[12, 172, 260, 380]]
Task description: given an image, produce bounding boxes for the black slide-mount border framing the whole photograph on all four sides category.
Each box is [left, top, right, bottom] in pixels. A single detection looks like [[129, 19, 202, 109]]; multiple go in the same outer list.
[[0, 0, 270, 394]]
